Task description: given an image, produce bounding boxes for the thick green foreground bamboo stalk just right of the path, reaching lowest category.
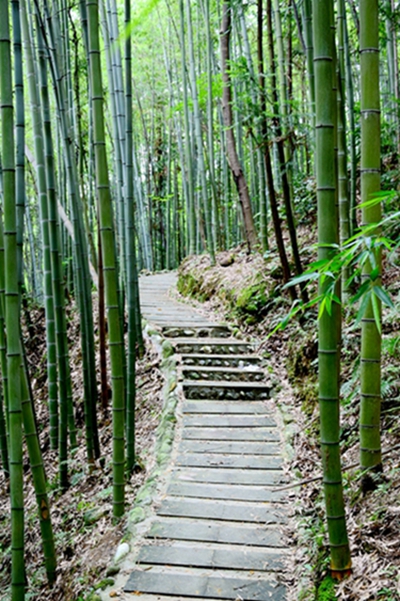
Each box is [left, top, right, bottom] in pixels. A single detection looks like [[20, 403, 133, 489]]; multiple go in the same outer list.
[[313, 0, 351, 578]]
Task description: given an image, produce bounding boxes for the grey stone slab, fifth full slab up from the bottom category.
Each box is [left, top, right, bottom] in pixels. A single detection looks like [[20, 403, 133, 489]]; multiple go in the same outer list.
[[167, 481, 287, 503]]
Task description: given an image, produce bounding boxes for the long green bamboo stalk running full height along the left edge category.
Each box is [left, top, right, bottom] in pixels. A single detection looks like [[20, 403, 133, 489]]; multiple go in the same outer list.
[[0, 0, 25, 601]]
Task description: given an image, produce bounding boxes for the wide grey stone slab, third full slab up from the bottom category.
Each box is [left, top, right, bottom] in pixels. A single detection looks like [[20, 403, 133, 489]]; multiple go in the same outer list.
[[147, 517, 285, 547]]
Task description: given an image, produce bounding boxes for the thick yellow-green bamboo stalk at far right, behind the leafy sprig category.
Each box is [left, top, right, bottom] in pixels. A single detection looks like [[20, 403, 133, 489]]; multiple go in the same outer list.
[[360, 0, 382, 488]]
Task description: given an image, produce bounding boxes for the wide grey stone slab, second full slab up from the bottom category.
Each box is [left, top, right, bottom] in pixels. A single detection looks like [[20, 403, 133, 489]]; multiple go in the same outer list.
[[138, 541, 284, 572]]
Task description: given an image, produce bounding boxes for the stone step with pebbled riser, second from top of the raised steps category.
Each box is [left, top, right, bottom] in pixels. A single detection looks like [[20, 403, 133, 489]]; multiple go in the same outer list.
[[171, 337, 253, 355]]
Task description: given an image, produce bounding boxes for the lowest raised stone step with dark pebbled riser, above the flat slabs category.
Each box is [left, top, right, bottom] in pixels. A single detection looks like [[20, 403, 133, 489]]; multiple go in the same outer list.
[[182, 380, 272, 401]]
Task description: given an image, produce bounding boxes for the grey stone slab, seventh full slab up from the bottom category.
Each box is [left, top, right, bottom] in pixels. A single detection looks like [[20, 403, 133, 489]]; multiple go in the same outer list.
[[176, 453, 283, 470]]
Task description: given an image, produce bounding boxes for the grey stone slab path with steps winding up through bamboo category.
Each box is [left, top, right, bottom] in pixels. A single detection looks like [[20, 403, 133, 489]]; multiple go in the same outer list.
[[124, 273, 287, 601]]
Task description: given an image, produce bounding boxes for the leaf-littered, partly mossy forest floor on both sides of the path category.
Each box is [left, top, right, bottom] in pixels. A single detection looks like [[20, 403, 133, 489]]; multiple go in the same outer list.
[[0, 236, 400, 601]]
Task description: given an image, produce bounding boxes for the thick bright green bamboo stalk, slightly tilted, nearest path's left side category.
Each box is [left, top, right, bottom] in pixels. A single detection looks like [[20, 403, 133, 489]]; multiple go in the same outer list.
[[86, 0, 125, 517]]
